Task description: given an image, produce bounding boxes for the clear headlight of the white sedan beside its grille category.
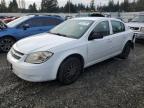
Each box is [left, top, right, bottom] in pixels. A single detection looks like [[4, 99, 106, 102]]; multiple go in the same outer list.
[[25, 51, 53, 64]]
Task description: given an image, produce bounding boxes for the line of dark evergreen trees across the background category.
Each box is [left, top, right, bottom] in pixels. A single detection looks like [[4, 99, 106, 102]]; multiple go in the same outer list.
[[0, 0, 144, 13]]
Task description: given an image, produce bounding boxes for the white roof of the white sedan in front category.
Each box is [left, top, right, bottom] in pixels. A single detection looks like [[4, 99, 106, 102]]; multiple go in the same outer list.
[[73, 17, 121, 22]]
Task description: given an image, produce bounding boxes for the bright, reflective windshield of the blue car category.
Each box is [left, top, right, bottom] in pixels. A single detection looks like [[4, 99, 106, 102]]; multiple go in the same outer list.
[[7, 16, 30, 27]]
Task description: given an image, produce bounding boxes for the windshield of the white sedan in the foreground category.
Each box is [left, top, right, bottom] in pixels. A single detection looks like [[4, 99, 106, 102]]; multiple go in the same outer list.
[[49, 20, 93, 39]]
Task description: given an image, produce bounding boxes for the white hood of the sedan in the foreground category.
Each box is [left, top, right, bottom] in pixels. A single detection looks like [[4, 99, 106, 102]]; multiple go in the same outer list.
[[14, 33, 76, 54]]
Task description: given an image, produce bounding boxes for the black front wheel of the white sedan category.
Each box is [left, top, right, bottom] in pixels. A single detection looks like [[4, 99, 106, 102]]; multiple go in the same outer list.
[[57, 57, 83, 85]]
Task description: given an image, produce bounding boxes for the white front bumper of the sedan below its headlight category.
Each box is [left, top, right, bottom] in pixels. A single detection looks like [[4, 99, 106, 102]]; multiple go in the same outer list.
[[7, 52, 56, 82]]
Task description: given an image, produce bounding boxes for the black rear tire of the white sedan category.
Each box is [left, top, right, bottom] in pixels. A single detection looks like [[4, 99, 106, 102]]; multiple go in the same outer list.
[[119, 42, 131, 59]]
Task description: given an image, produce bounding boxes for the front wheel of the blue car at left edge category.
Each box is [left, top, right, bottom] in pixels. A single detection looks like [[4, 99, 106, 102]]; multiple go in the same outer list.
[[0, 37, 16, 53]]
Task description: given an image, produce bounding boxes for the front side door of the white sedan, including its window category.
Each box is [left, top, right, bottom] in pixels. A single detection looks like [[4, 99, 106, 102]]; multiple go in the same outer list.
[[88, 21, 113, 64]]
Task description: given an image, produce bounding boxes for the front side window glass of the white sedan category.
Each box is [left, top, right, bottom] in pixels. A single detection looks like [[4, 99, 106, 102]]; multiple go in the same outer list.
[[94, 21, 110, 36]]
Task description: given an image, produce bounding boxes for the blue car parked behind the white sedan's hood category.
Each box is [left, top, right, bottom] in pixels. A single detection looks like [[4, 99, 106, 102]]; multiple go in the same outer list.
[[0, 15, 64, 52]]
